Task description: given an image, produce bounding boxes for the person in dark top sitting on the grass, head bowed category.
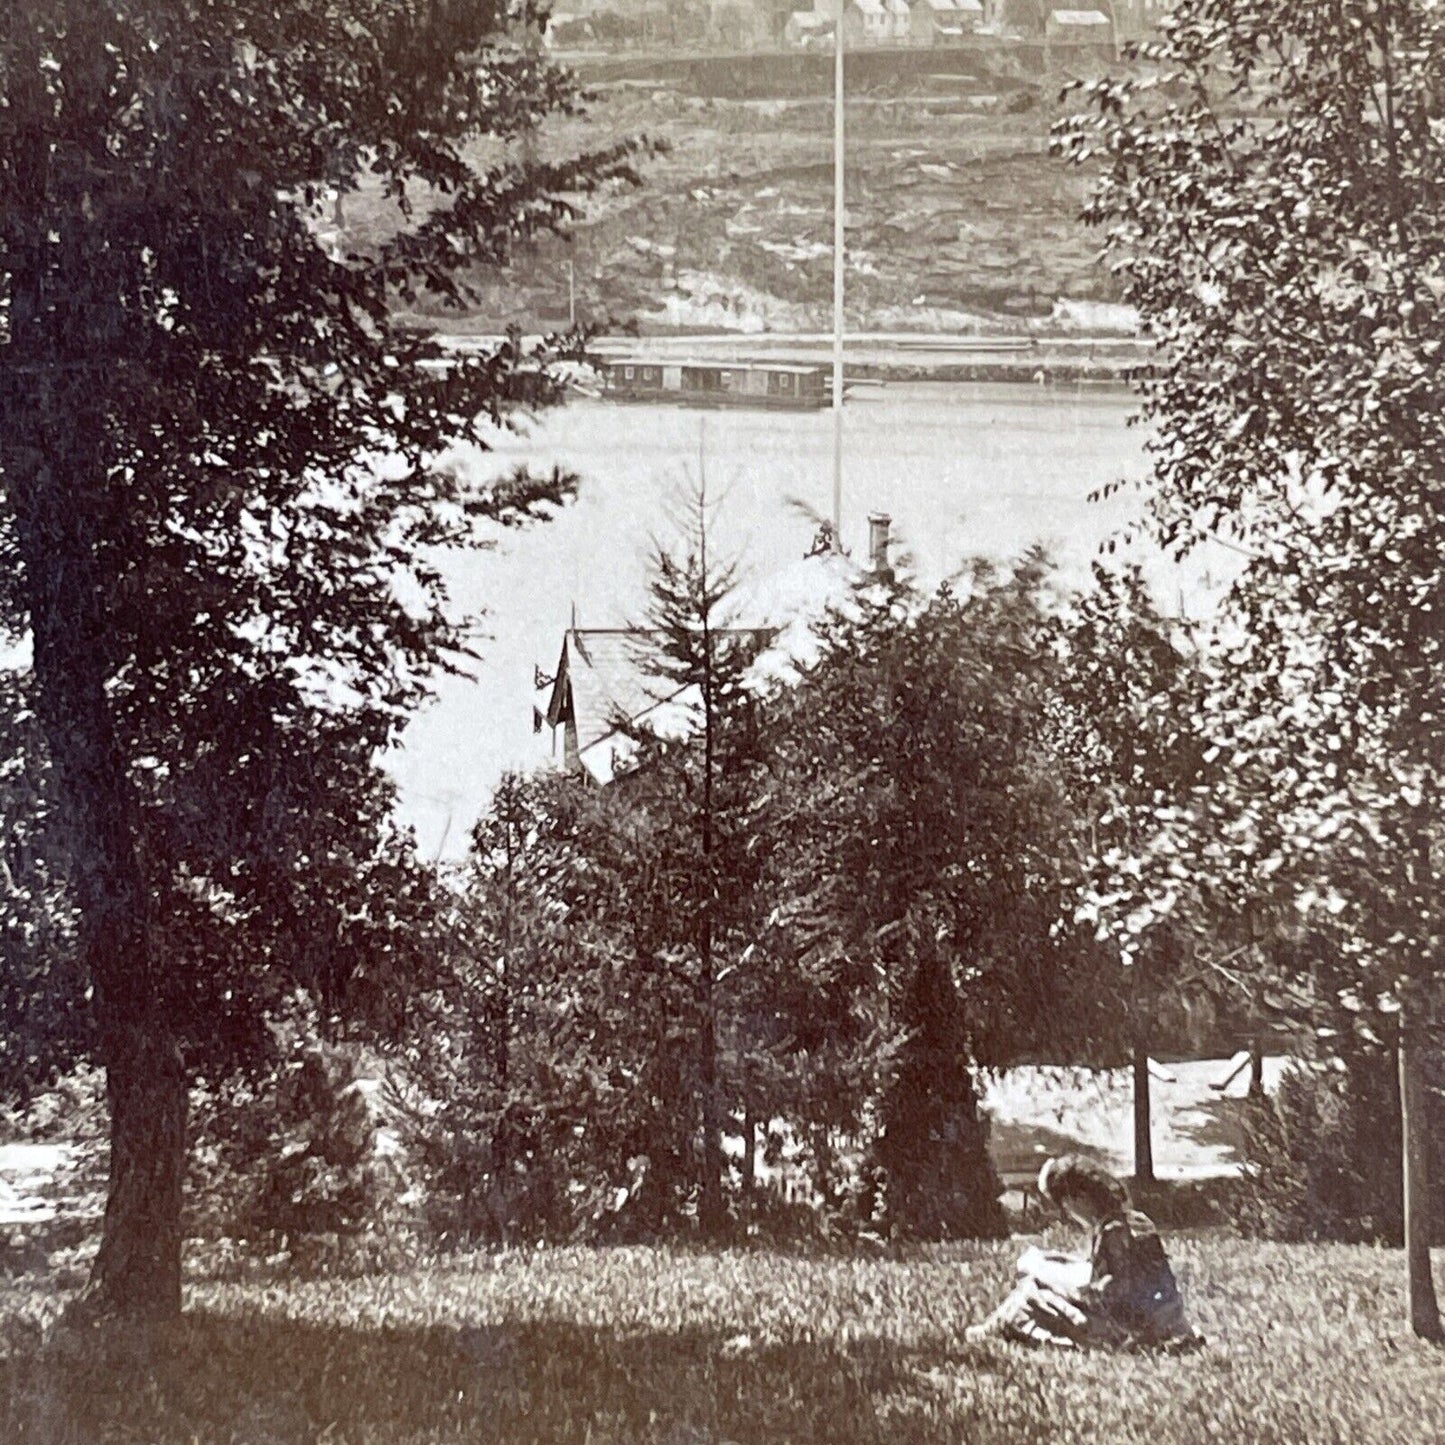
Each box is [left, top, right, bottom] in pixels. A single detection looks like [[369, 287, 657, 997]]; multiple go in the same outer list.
[[968, 1155, 1199, 1348]]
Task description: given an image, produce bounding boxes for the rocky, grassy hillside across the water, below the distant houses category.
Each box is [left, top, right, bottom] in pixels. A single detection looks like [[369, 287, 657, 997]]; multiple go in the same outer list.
[[390, 48, 1130, 334]]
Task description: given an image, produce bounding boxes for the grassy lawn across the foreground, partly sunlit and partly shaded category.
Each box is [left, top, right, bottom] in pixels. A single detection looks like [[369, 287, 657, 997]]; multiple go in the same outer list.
[[0, 1235, 1445, 1445]]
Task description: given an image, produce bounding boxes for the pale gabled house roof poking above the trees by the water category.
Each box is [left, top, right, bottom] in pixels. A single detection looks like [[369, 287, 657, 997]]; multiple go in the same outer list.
[[539, 627, 776, 783]]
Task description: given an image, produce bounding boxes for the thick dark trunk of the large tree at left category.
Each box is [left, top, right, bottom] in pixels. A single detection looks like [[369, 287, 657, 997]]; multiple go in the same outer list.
[[0, 338, 186, 1318]]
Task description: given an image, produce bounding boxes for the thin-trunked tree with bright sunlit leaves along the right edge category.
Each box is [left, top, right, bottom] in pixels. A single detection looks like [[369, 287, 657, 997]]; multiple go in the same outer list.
[[1059, 0, 1445, 1337]]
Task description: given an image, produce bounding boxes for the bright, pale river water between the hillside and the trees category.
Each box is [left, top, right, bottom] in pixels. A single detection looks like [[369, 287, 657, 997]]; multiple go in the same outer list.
[[390, 384, 1228, 857]]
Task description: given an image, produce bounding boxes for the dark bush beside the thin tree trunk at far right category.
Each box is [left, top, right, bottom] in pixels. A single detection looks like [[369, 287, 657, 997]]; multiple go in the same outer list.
[[1228, 1049, 1445, 1244]]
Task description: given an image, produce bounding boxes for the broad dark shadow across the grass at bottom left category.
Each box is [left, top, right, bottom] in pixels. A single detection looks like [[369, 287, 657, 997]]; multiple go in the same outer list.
[[0, 1312, 976, 1445]]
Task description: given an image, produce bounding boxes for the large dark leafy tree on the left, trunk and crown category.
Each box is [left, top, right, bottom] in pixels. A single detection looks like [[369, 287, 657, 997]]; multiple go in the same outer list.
[[0, 0, 644, 1315]]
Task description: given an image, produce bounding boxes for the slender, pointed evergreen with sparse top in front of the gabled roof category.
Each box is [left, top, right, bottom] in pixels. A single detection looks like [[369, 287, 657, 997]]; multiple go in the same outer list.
[[618, 483, 773, 1235]]
